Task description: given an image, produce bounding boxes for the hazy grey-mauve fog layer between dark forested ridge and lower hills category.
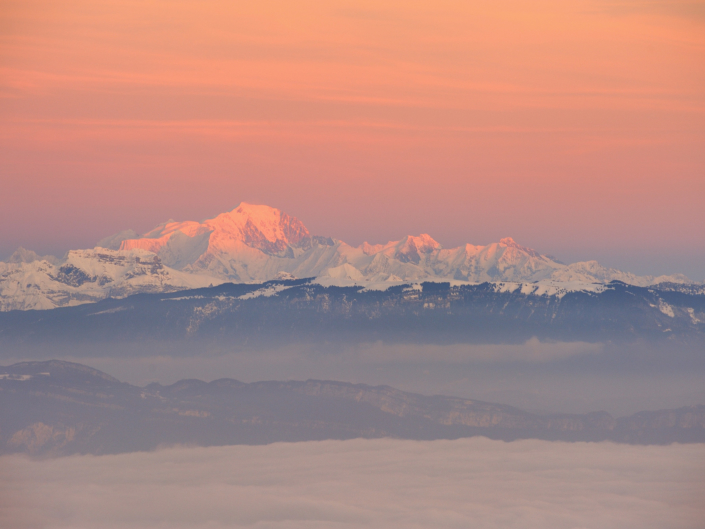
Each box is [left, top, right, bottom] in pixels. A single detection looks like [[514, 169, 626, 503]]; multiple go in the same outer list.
[[2, 339, 705, 416]]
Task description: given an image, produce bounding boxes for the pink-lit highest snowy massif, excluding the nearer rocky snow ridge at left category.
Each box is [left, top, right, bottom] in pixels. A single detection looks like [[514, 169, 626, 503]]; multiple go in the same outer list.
[[111, 203, 687, 285]]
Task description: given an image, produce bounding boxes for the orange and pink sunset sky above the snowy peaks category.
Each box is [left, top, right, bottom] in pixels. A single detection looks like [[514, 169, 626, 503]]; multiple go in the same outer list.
[[0, 0, 705, 280]]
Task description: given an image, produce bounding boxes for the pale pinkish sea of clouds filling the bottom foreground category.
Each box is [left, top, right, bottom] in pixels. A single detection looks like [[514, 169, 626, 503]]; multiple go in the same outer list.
[[0, 438, 705, 529]]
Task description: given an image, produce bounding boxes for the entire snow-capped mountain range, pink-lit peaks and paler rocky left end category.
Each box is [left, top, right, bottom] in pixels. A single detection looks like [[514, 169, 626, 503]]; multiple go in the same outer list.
[[0, 203, 691, 311]]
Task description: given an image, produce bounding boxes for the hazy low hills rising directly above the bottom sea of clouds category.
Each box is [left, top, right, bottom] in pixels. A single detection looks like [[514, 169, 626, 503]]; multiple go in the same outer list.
[[0, 360, 705, 456]]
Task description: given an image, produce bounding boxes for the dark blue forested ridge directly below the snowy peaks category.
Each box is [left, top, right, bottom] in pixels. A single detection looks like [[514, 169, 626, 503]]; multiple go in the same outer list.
[[0, 280, 705, 350]]
